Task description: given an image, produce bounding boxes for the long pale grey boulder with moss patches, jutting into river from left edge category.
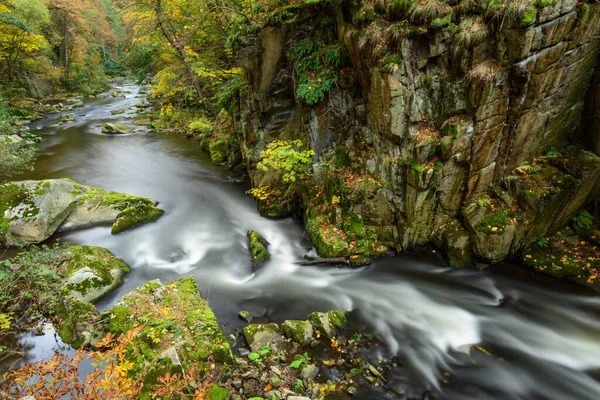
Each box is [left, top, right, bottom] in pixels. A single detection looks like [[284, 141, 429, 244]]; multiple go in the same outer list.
[[0, 179, 163, 246]]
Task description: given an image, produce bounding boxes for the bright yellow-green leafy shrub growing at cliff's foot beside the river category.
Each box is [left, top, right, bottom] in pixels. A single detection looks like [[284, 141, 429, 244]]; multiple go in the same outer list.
[[258, 140, 315, 184]]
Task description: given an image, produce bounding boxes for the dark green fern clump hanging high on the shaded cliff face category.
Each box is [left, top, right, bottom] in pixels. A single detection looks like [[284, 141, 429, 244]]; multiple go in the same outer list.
[[290, 39, 346, 106]]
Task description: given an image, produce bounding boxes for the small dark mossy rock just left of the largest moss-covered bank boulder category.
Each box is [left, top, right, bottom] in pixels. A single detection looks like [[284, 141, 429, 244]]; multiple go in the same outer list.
[[54, 296, 100, 349]]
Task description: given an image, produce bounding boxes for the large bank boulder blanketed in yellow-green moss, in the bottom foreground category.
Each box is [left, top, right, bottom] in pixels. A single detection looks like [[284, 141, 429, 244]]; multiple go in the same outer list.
[[107, 277, 234, 399]]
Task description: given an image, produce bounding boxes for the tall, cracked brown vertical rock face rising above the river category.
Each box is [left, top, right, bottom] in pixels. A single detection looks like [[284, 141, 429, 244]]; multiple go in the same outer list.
[[225, 0, 600, 264]]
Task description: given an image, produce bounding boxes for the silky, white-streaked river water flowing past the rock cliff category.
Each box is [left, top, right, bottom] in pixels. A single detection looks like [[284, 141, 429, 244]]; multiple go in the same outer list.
[[4, 85, 600, 400]]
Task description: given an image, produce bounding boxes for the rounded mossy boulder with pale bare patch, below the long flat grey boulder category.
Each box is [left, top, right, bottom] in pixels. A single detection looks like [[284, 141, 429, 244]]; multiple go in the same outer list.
[[64, 246, 129, 302]]
